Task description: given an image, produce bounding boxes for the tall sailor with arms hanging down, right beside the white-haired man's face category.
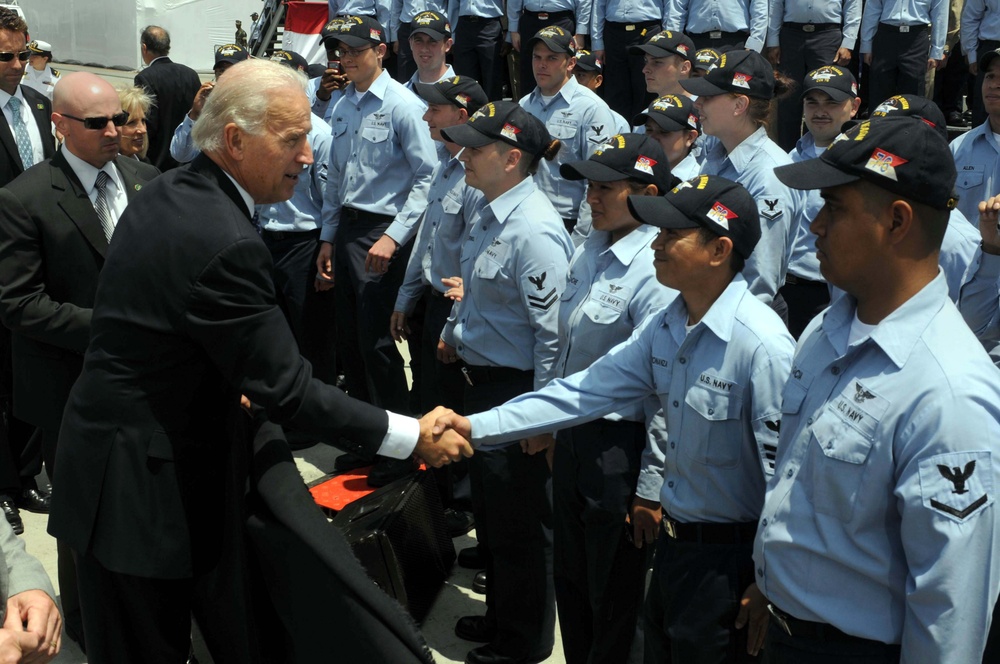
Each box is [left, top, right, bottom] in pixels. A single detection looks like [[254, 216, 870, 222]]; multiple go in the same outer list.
[[316, 16, 438, 486]]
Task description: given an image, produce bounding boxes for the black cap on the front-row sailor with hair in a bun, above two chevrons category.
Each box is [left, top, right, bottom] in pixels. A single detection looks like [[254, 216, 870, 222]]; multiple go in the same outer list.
[[441, 101, 552, 156]]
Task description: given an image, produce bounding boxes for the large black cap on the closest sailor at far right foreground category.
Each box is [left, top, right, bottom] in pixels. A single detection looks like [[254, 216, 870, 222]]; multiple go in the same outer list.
[[774, 115, 958, 210]]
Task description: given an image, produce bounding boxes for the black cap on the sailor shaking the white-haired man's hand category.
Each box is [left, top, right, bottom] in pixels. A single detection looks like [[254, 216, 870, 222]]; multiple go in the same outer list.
[[628, 175, 760, 259]]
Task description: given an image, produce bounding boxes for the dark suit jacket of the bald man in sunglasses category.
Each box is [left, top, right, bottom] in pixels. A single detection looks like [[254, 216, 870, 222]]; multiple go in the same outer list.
[[0, 150, 159, 429]]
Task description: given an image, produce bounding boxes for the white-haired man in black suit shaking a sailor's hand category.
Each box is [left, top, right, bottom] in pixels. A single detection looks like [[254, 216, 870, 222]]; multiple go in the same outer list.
[[49, 60, 472, 663]]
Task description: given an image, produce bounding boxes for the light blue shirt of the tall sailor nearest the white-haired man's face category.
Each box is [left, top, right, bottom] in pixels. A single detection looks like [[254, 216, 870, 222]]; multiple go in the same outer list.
[[320, 71, 438, 245]]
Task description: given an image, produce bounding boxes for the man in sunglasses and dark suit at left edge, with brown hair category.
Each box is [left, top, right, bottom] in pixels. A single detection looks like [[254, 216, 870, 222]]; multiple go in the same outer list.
[[0, 7, 55, 534]]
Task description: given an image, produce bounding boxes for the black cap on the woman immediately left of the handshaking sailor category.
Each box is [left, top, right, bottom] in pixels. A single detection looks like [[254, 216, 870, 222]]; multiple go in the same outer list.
[[559, 134, 680, 194]]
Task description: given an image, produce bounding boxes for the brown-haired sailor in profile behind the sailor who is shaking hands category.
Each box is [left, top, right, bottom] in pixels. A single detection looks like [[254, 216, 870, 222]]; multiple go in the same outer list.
[[681, 51, 806, 317]]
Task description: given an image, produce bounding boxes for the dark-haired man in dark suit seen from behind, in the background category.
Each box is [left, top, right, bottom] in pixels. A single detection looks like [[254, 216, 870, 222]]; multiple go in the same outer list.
[[135, 25, 201, 171]]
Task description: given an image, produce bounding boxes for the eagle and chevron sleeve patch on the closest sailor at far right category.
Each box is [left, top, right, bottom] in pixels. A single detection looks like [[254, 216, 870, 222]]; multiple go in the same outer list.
[[920, 451, 995, 523]]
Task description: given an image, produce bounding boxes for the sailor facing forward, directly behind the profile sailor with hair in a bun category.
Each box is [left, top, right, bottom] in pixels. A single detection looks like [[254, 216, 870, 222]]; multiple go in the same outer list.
[[520, 26, 615, 230]]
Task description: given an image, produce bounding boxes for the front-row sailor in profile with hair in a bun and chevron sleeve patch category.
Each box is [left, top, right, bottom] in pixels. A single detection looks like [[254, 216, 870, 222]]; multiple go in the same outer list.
[[438, 102, 573, 664]]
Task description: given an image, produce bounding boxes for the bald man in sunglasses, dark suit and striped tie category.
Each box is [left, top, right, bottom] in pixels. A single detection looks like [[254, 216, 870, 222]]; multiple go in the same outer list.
[[0, 73, 159, 641]]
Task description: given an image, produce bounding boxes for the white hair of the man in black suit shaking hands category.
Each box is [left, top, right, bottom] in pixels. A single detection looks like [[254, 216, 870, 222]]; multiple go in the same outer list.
[[191, 59, 306, 152]]
